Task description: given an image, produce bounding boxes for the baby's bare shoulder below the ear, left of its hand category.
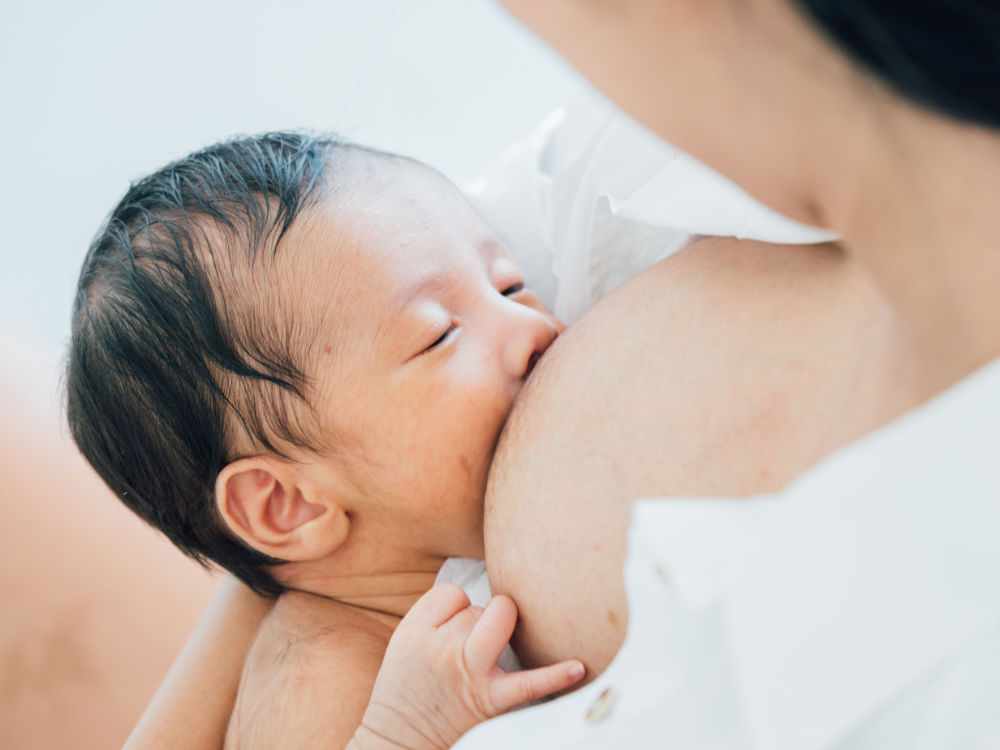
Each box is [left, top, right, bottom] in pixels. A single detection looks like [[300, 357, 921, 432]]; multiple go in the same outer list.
[[226, 592, 392, 750]]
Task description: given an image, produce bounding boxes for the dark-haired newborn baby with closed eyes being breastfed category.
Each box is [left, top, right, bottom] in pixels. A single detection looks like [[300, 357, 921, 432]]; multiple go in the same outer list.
[[67, 133, 582, 748]]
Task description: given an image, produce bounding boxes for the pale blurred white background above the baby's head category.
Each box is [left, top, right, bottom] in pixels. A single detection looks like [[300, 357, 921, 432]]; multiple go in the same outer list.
[[0, 0, 583, 374]]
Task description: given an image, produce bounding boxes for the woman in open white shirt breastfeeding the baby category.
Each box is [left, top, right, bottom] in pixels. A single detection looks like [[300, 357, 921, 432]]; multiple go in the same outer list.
[[470, 0, 1000, 748]]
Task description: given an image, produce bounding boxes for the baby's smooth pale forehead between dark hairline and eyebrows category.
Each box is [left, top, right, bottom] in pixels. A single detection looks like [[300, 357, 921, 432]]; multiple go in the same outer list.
[[274, 160, 496, 335]]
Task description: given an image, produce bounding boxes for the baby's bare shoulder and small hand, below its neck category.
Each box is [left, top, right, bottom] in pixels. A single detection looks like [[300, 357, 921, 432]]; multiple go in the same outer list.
[[226, 583, 585, 750]]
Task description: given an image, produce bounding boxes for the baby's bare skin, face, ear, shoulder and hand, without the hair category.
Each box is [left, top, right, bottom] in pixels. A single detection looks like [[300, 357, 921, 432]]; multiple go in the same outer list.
[[216, 154, 583, 749]]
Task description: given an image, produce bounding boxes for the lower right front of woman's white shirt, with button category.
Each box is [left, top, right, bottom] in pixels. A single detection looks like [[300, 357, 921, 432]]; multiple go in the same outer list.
[[458, 354, 1000, 750]]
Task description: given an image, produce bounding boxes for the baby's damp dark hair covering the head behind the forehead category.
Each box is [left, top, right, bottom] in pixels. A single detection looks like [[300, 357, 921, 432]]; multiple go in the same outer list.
[[67, 133, 374, 595]]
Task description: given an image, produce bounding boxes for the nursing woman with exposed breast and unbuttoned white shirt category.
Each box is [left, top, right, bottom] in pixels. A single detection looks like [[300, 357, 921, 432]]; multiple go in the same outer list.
[[127, 0, 1000, 748]]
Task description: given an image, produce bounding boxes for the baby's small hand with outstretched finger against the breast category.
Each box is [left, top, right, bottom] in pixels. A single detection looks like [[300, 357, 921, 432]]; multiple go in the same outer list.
[[348, 583, 584, 750]]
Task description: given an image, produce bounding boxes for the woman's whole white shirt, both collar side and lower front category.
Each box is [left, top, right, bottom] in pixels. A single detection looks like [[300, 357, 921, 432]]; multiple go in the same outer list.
[[458, 97, 1000, 750]]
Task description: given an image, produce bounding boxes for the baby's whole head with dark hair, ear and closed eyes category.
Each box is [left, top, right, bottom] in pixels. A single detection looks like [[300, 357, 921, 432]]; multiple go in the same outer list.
[[67, 133, 558, 593]]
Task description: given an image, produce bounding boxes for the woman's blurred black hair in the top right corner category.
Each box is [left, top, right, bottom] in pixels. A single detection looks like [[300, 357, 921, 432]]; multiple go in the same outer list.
[[794, 0, 1000, 127]]
